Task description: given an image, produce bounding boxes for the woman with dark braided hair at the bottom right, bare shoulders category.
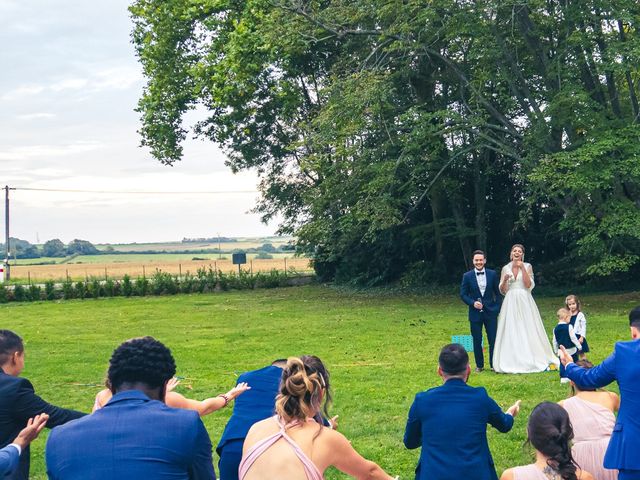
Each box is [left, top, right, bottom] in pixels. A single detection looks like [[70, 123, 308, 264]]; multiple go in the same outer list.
[[500, 402, 594, 480]]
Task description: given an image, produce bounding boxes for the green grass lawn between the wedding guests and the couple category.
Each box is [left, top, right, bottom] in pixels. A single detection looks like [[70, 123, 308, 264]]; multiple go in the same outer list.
[[0, 286, 640, 479]]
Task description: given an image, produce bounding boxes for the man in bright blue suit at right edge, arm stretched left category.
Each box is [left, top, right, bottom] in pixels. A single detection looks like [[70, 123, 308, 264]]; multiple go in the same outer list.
[[560, 307, 640, 480]]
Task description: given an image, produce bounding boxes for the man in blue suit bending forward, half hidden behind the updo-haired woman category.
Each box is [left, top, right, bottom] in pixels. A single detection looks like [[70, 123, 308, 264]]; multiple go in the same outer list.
[[216, 359, 287, 480]]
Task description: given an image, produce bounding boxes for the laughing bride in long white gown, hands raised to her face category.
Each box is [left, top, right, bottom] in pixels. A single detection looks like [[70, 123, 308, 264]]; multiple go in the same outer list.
[[493, 244, 558, 373]]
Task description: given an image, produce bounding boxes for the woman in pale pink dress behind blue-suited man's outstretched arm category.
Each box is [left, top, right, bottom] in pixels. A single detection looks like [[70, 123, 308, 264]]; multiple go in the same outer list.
[[558, 360, 620, 480]]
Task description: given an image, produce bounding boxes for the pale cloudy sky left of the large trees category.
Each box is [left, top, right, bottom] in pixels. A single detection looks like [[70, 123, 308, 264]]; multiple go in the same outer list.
[[0, 0, 276, 243]]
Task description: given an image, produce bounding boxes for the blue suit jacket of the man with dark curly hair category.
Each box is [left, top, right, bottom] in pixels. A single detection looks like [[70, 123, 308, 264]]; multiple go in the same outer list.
[[46, 390, 216, 480]]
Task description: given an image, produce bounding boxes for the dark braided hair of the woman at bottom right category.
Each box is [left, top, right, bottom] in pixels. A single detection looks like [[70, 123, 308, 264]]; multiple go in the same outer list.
[[527, 402, 578, 480]]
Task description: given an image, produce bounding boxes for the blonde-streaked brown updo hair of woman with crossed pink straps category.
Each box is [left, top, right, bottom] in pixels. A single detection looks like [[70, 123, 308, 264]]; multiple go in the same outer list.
[[276, 355, 331, 423]]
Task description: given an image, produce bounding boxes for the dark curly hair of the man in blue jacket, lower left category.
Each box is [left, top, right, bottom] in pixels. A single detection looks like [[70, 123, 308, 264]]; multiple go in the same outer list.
[[107, 337, 176, 393]]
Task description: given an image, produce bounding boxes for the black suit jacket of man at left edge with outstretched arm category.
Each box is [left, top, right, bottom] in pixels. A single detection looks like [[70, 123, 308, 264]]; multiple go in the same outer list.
[[0, 369, 86, 480]]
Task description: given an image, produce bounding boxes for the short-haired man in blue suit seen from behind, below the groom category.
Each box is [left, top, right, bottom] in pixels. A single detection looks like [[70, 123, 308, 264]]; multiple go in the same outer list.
[[404, 343, 520, 480]]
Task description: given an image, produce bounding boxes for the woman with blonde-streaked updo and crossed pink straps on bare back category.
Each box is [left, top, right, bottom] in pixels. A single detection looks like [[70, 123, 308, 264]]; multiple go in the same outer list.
[[238, 355, 392, 480]]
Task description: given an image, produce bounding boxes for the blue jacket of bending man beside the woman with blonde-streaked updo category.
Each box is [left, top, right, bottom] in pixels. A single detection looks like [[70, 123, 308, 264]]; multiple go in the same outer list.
[[216, 366, 282, 454]]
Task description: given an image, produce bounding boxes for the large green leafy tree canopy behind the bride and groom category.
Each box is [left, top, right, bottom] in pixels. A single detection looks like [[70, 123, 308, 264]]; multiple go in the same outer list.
[[130, 0, 640, 284]]
